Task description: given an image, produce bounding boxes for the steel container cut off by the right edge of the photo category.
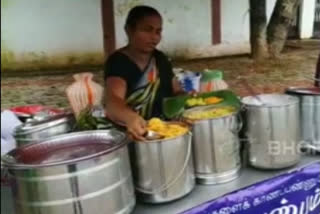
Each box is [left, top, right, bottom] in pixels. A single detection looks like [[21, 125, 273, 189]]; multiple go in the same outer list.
[[286, 87, 320, 151]]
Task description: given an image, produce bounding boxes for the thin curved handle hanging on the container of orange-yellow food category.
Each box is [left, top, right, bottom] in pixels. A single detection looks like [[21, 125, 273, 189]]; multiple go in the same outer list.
[[135, 132, 192, 194]]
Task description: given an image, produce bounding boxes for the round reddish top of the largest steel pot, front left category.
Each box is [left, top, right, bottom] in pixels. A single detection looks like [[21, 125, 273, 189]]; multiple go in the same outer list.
[[2, 130, 127, 169]]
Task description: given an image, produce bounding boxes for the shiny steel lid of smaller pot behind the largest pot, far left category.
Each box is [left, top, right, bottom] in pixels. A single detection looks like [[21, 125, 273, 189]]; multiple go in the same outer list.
[[14, 113, 74, 136]]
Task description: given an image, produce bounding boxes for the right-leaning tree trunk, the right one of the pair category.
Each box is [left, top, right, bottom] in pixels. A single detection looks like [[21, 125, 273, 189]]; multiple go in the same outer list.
[[267, 0, 302, 58]]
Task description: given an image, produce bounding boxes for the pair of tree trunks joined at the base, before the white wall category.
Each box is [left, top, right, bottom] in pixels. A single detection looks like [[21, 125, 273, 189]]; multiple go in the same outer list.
[[250, 0, 302, 60]]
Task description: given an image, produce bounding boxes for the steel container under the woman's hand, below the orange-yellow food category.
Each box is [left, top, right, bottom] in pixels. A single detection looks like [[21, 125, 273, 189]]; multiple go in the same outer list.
[[131, 123, 195, 203]]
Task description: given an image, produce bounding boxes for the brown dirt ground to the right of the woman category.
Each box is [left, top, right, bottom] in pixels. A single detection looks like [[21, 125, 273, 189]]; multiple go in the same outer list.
[[175, 40, 320, 96]]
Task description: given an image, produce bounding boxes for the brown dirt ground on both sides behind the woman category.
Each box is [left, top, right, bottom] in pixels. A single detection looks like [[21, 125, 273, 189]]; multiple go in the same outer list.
[[1, 40, 320, 109]]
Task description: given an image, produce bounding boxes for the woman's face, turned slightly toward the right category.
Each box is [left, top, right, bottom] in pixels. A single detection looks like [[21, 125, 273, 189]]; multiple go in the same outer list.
[[128, 15, 162, 53]]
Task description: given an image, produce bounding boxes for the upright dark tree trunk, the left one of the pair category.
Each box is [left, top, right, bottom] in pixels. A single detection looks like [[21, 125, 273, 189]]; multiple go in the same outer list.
[[250, 0, 269, 60]]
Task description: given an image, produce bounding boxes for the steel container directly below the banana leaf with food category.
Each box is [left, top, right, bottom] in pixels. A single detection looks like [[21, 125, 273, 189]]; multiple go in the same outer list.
[[184, 107, 242, 185]]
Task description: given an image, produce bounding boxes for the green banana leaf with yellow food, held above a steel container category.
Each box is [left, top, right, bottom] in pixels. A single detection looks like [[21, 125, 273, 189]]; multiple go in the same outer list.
[[162, 90, 241, 119]]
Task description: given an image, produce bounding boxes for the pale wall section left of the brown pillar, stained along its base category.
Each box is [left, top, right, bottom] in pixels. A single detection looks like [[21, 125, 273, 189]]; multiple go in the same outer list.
[[1, 0, 103, 70]]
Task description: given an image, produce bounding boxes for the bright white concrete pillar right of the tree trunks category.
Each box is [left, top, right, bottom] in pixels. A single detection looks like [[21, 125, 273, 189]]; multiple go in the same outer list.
[[299, 0, 316, 39]]
